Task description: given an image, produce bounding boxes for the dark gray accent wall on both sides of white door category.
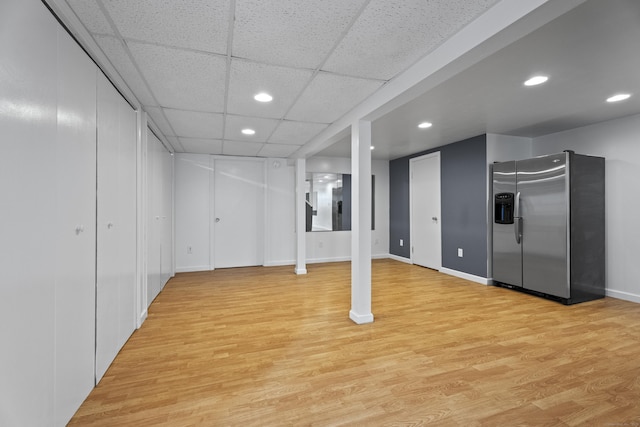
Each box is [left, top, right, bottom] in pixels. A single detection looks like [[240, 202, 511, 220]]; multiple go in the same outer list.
[[389, 135, 488, 277]]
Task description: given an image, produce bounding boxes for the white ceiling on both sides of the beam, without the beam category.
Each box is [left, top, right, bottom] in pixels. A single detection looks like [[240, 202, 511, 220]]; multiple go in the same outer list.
[[53, 0, 640, 159]]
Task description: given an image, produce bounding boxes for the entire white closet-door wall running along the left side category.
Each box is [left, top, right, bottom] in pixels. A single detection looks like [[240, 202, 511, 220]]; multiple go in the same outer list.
[[0, 0, 174, 427]]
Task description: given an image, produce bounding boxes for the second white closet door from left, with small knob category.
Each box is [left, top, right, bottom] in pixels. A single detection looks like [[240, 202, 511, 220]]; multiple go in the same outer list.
[[51, 28, 96, 425]]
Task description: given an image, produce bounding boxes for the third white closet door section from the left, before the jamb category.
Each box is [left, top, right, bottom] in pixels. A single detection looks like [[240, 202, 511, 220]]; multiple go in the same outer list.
[[96, 73, 136, 381]]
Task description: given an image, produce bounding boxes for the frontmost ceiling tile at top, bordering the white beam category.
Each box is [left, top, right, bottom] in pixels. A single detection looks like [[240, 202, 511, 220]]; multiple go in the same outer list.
[[322, 0, 497, 80]]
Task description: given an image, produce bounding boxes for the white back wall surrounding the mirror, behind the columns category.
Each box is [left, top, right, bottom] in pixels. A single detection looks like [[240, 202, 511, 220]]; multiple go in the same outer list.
[[306, 157, 389, 263]]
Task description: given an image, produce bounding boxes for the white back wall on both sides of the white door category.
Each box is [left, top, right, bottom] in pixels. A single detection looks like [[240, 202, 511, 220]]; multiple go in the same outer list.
[[175, 154, 295, 272]]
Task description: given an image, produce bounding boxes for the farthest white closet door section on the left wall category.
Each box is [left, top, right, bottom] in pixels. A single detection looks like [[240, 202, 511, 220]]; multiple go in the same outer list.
[[147, 131, 174, 305]]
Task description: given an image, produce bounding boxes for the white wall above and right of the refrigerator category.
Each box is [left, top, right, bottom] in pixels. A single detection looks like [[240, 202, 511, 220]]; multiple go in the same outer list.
[[533, 115, 640, 302]]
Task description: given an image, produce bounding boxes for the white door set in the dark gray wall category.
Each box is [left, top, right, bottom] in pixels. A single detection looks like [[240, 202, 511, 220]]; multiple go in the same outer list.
[[409, 152, 442, 270]]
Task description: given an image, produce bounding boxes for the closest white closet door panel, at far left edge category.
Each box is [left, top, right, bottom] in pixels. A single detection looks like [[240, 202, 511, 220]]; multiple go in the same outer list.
[[0, 0, 57, 426]]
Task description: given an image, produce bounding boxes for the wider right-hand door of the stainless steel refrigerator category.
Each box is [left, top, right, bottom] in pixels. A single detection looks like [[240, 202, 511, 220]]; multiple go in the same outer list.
[[517, 153, 570, 298]]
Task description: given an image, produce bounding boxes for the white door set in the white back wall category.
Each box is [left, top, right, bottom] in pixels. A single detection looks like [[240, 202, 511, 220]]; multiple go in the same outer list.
[[213, 159, 265, 268]]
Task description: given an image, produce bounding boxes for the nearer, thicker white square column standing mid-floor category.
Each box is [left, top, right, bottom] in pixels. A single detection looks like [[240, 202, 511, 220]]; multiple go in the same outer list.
[[349, 120, 373, 324]]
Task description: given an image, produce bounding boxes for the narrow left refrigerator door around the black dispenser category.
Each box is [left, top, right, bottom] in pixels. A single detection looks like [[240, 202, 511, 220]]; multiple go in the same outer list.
[[492, 162, 522, 286]]
